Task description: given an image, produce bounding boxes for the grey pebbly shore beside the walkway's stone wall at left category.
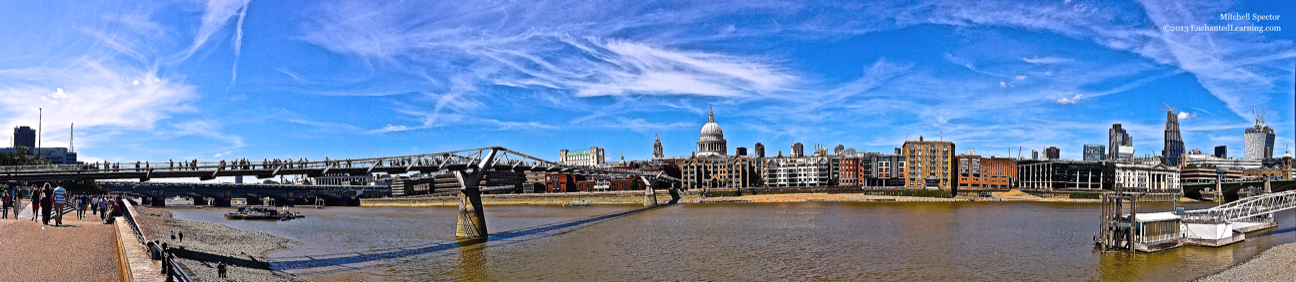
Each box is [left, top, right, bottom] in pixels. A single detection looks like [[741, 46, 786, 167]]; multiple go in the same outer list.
[[136, 207, 299, 281]]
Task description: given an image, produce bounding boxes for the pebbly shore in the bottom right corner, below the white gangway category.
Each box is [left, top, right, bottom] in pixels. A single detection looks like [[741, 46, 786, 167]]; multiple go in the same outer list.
[[1198, 243, 1296, 282]]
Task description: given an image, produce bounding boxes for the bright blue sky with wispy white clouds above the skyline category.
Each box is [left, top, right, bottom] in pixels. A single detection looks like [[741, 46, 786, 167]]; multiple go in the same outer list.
[[0, 0, 1296, 162]]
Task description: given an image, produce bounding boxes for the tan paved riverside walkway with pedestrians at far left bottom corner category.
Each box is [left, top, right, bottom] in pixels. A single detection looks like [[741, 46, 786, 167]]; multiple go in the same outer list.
[[0, 199, 122, 281]]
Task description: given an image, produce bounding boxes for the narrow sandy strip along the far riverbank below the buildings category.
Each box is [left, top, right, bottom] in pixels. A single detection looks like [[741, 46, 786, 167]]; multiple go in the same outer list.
[[360, 190, 1100, 207]]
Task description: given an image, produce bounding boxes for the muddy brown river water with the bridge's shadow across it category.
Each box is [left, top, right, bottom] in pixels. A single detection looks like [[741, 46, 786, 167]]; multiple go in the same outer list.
[[171, 202, 1296, 281]]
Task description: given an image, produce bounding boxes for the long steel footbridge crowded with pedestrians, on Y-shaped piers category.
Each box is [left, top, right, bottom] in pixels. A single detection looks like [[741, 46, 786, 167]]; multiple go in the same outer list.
[[0, 146, 679, 238]]
